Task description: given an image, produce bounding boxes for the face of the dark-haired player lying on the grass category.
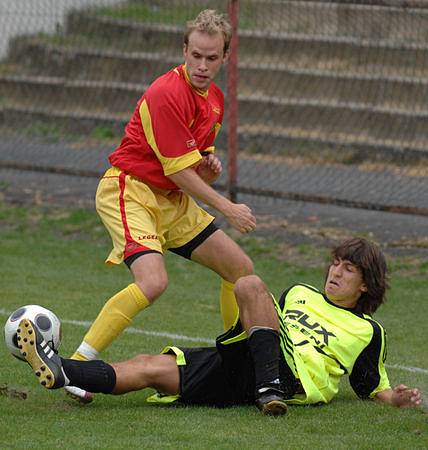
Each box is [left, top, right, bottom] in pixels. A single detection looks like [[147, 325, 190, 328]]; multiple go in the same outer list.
[[325, 258, 367, 308]]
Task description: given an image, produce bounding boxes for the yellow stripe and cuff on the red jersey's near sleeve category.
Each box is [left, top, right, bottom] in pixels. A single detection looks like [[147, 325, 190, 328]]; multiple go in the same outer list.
[[139, 100, 202, 176]]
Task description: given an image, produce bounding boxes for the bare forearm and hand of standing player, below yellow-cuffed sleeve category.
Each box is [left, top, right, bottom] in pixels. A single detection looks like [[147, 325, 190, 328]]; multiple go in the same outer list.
[[169, 167, 256, 233]]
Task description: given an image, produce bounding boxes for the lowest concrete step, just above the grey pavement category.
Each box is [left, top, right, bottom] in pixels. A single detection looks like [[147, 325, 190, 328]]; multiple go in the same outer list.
[[0, 105, 428, 162]]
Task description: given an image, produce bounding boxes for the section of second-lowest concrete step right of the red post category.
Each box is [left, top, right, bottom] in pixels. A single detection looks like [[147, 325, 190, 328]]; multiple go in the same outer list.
[[239, 97, 428, 147]]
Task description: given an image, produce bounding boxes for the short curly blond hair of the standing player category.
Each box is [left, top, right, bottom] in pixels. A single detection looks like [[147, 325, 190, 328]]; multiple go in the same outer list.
[[184, 9, 232, 54]]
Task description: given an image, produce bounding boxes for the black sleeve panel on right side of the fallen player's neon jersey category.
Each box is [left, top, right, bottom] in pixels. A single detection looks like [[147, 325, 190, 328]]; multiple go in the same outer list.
[[349, 319, 386, 398]]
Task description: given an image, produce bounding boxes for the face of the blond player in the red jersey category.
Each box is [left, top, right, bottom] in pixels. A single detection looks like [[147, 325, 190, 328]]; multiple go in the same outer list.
[[183, 31, 227, 90]]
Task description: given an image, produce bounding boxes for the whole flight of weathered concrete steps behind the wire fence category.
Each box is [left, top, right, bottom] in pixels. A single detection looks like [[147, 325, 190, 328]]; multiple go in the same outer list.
[[0, 2, 428, 160]]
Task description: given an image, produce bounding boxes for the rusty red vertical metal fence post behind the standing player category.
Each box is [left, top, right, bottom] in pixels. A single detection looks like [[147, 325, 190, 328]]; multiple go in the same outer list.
[[227, 0, 239, 202]]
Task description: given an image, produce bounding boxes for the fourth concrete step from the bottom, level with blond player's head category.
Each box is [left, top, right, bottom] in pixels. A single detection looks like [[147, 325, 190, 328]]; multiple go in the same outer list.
[[66, 13, 428, 77]]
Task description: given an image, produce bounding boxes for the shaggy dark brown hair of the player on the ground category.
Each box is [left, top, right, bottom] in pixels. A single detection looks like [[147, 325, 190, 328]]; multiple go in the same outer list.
[[331, 238, 389, 314]]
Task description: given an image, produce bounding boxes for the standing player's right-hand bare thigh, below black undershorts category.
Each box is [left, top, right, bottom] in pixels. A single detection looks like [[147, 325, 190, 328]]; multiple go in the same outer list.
[[191, 230, 254, 283]]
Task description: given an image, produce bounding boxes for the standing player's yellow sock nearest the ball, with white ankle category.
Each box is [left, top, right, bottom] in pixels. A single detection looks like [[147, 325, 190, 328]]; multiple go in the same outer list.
[[71, 283, 150, 360]]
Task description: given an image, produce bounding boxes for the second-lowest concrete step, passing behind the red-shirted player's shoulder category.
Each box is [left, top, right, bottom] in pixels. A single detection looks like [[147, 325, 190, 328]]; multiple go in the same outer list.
[[0, 75, 428, 142]]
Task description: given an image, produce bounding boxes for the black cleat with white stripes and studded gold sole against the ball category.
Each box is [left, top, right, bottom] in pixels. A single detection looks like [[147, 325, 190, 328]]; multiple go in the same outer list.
[[16, 319, 66, 389]]
